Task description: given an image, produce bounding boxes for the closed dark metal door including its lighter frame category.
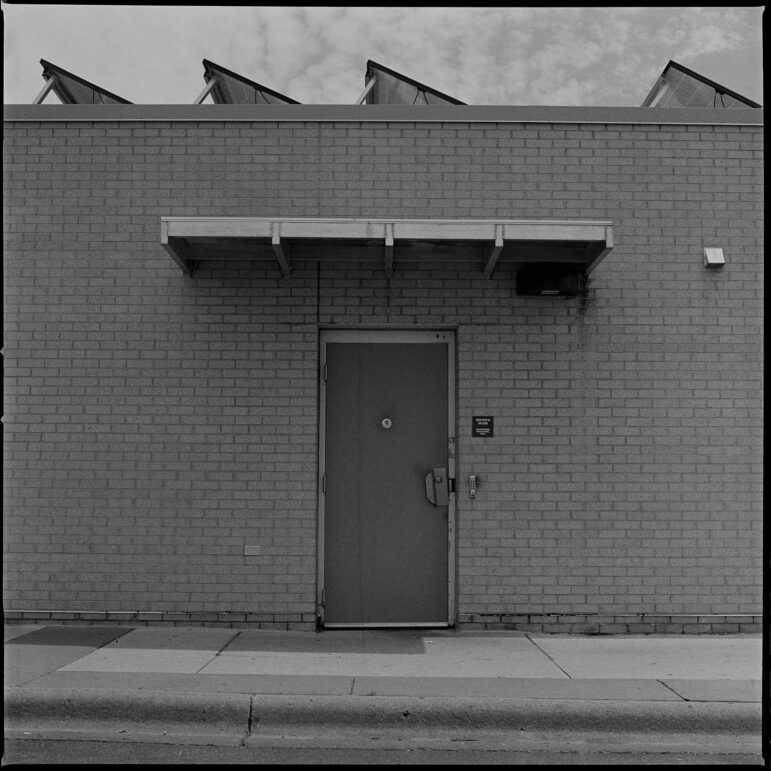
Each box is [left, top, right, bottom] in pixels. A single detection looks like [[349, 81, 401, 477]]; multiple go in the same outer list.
[[319, 331, 454, 627]]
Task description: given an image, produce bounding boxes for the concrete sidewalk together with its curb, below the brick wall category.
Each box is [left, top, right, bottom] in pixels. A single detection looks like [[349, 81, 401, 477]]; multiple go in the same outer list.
[[4, 625, 762, 758]]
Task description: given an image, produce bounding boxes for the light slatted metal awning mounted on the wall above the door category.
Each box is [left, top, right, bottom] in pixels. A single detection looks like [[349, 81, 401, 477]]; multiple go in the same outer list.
[[161, 217, 613, 278]]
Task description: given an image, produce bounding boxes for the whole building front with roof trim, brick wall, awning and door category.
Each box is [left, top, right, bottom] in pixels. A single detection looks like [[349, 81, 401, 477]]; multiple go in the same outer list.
[[4, 95, 763, 632]]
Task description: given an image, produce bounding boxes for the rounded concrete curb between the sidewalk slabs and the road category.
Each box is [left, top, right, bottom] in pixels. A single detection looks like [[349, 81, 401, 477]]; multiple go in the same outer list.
[[5, 688, 762, 736]]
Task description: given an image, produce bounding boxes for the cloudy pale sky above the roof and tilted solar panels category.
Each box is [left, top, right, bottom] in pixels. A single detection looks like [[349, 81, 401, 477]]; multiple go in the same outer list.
[[2, 2, 763, 107]]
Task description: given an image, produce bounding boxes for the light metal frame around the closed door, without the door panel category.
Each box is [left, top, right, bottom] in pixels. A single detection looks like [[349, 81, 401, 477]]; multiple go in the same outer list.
[[316, 328, 457, 629]]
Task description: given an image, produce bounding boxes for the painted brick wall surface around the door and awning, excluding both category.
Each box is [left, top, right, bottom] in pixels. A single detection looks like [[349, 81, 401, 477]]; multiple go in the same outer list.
[[4, 116, 763, 626]]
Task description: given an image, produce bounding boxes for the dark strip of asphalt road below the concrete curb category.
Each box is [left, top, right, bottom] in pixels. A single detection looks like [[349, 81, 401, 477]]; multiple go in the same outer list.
[[3, 738, 763, 766]]
